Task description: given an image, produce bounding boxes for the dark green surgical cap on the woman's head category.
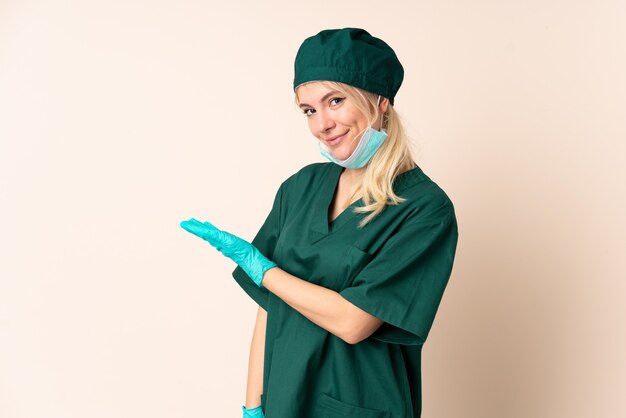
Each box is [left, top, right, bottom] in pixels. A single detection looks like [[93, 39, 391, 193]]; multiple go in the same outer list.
[[293, 28, 404, 105]]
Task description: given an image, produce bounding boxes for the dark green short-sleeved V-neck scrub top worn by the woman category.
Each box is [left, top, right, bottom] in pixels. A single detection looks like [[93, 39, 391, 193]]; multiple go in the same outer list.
[[233, 163, 458, 418]]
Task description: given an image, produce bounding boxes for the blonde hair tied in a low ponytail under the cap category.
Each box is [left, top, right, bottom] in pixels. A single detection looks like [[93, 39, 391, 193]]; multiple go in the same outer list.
[[296, 81, 415, 228]]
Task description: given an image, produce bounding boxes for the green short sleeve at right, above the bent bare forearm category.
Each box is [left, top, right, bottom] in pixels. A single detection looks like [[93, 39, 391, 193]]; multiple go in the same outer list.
[[340, 209, 458, 345]]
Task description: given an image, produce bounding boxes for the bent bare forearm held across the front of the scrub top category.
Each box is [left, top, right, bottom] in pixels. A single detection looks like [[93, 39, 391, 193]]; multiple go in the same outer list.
[[263, 267, 383, 344]]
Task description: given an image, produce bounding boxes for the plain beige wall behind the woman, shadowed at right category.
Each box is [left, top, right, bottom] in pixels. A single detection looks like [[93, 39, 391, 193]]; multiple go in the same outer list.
[[0, 0, 626, 418]]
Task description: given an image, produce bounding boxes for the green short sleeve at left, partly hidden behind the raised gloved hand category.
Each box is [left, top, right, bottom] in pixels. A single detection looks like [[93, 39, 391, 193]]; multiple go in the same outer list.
[[232, 184, 283, 310]]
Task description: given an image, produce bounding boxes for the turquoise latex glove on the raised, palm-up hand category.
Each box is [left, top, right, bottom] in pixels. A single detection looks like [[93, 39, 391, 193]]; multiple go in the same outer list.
[[180, 218, 276, 287]]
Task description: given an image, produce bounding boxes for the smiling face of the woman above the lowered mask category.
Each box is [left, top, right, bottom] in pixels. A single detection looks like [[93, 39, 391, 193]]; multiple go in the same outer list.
[[296, 82, 376, 160]]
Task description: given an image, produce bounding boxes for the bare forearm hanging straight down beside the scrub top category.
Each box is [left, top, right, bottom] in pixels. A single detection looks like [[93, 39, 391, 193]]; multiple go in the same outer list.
[[245, 306, 267, 408]]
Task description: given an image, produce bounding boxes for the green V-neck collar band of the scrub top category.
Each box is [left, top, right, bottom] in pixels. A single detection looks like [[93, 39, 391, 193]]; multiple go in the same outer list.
[[311, 163, 426, 241]]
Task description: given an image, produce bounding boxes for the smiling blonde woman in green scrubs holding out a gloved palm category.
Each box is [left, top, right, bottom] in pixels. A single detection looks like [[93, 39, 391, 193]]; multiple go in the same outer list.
[[181, 28, 458, 418]]
